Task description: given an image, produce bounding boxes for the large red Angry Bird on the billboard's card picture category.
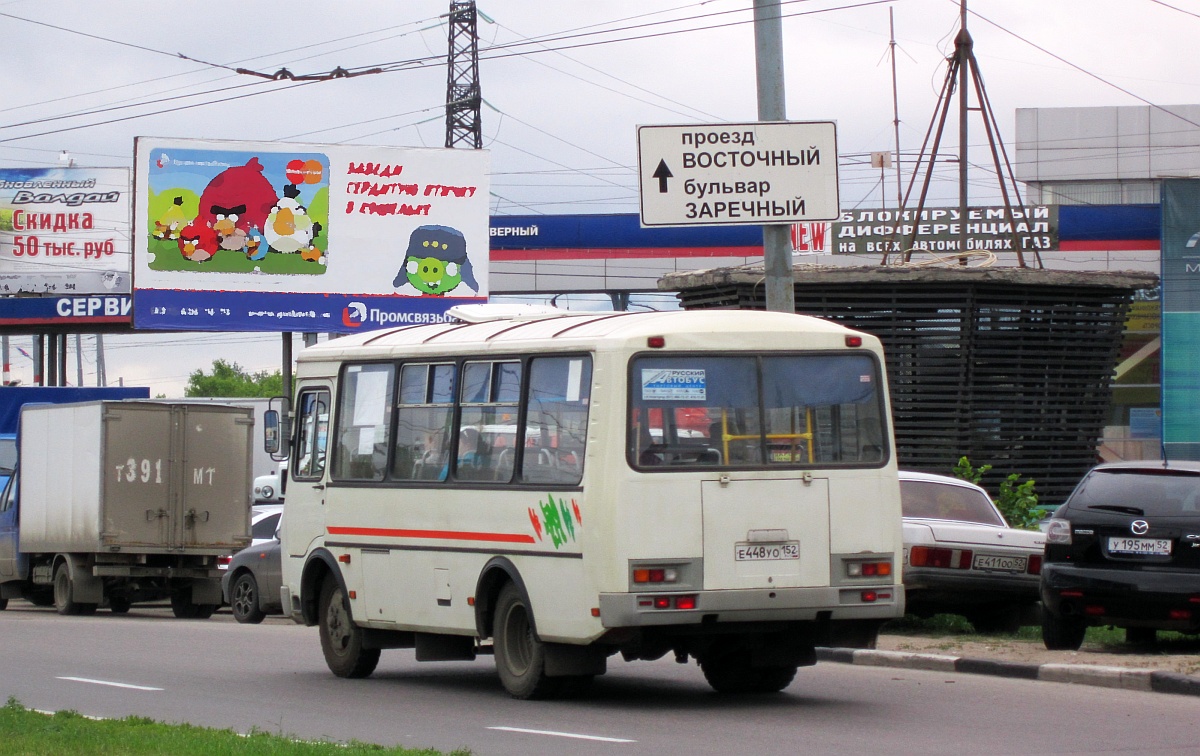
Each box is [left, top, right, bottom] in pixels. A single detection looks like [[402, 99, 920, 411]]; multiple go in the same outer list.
[[197, 157, 280, 250]]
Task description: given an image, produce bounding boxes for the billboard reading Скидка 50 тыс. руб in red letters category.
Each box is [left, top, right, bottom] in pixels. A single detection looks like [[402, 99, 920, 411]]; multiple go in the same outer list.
[[0, 168, 131, 295]]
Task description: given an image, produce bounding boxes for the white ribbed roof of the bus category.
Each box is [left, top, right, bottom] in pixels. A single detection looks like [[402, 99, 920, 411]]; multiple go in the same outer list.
[[298, 310, 878, 361]]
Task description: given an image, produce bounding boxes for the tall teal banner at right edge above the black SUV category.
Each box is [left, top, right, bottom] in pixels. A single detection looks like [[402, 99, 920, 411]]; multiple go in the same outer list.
[[1160, 179, 1200, 460]]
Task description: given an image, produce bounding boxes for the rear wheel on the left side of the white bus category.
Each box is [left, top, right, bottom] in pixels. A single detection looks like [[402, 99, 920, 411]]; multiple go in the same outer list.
[[492, 583, 559, 698]]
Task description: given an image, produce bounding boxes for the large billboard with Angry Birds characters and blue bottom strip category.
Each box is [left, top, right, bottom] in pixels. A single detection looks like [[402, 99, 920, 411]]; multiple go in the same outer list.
[[133, 137, 488, 332]]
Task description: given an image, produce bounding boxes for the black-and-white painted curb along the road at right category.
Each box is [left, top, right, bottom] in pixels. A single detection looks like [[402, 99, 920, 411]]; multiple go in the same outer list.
[[817, 648, 1200, 696]]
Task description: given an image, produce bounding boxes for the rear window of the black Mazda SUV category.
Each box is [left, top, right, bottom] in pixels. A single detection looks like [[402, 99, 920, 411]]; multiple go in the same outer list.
[[1070, 469, 1200, 516]]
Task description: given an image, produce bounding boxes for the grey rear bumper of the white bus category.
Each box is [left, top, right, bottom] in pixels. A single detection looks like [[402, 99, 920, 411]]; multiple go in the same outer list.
[[600, 583, 904, 629]]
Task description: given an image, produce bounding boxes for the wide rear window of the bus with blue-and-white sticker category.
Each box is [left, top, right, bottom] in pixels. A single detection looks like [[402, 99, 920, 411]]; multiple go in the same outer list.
[[626, 353, 887, 470]]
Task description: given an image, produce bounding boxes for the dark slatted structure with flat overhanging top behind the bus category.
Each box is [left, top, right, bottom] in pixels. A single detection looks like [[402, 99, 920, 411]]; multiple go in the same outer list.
[[659, 266, 1158, 504]]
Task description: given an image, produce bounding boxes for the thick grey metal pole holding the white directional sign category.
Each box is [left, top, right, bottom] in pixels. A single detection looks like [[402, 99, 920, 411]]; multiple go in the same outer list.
[[754, 0, 796, 312]]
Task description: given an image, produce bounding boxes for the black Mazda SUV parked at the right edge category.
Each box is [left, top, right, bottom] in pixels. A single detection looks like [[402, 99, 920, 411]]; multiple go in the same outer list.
[[1042, 462, 1200, 650]]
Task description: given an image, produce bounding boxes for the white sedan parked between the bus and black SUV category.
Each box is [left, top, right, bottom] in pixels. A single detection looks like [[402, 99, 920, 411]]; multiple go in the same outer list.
[[900, 472, 1045, 632]]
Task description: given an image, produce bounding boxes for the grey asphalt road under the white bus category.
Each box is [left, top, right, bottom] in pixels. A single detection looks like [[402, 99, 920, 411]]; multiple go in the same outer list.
[[0, 601, 1200, 756]]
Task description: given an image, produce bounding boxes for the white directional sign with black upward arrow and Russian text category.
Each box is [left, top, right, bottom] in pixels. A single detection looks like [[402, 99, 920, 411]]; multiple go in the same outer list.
[[637, 121, 839, 226]]
